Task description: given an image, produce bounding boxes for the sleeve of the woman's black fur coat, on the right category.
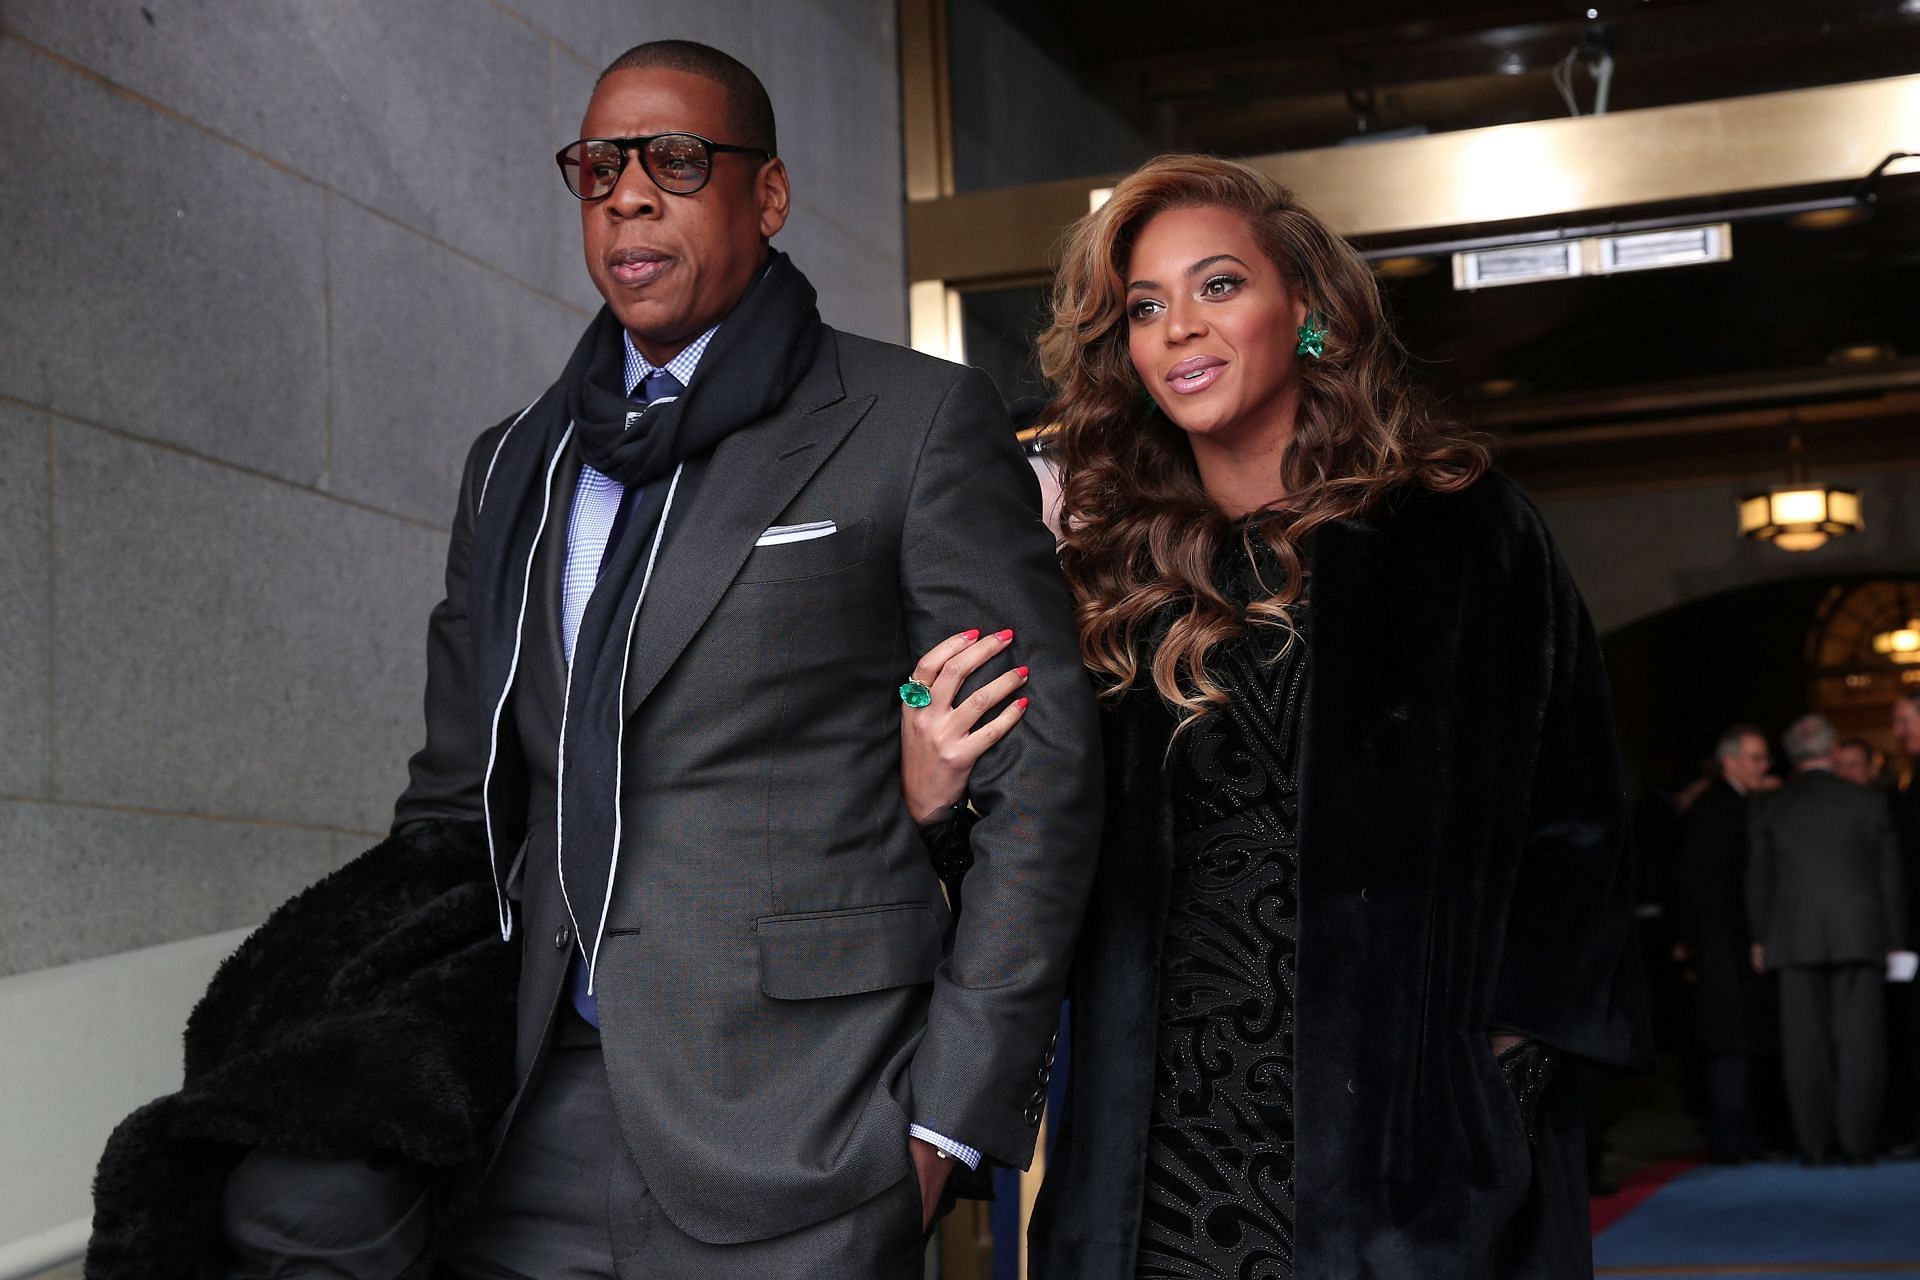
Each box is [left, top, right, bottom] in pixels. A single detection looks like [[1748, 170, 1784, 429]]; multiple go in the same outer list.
[[1494, 516, 1653, 1067]]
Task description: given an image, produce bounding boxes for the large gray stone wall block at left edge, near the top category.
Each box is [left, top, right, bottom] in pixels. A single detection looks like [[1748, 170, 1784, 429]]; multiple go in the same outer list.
[[0, 41, 326, 482]]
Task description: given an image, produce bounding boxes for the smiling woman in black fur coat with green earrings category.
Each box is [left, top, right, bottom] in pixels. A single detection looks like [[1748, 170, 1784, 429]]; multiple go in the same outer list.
[[902, 155, 1649, 1280]]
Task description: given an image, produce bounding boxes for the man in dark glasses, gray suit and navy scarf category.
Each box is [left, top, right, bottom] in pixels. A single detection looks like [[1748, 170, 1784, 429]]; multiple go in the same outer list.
[[228, 40, 1100, 1278]]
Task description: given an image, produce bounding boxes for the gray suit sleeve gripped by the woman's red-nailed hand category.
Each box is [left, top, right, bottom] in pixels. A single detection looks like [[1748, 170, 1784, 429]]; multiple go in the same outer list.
[[900, 370, 1102, 1169]]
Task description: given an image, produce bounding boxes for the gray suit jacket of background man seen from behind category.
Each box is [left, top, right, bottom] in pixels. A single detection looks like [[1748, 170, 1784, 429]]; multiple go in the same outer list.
[[1747, 770, 1907, 969]]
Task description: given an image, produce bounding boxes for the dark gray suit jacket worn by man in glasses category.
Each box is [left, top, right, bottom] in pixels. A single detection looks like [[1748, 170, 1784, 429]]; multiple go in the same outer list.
[[396, 332, 1100, 1242]]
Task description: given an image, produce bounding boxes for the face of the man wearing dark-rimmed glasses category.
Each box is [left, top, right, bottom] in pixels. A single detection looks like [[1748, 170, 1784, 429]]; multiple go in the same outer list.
[[580, 67, 789, 365]]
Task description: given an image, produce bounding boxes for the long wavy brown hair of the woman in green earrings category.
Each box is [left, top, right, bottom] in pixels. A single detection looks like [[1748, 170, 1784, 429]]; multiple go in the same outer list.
[[1039, 155, 1488, 729]]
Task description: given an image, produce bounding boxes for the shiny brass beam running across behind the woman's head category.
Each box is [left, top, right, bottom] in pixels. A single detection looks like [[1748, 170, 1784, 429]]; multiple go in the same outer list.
[[906, 75, 1920, 288]]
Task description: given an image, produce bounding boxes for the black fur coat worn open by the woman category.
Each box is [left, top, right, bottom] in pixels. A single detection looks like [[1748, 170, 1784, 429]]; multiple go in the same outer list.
[[1029, 476, 1651, 1280]]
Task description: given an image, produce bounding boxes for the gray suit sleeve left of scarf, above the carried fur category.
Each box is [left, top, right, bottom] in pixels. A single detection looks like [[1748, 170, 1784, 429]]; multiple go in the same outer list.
[[394, 426, 503, 831]]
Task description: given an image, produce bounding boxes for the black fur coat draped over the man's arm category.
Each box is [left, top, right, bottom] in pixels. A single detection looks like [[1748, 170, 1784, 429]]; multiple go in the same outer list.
[[86, 821, 520, 1280]]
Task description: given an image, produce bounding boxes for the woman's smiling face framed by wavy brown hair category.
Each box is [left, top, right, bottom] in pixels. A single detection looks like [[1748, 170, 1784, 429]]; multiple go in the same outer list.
[[1127, 209, 1308, 445]]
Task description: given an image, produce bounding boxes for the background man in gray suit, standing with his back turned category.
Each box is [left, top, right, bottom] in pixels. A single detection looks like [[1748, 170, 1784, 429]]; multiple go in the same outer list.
[[1747, 716, 1905, 1165]]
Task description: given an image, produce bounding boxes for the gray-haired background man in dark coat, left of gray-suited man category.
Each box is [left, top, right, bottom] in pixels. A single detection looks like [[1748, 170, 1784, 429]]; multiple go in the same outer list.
[[1678, 725, 1776, 1163]]
